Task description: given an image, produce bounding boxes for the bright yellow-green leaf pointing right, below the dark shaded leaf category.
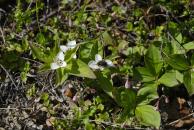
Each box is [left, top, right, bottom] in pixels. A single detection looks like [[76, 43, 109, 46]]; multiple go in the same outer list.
[[158, 71, 179, 87]]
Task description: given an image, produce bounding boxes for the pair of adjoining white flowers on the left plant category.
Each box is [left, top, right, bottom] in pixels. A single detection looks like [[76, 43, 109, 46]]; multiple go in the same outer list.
[[50, 40, 77, 70]]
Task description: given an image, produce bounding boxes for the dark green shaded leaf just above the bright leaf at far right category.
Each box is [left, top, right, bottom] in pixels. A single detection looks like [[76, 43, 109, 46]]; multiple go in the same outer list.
[[164, 54, 189, 70]]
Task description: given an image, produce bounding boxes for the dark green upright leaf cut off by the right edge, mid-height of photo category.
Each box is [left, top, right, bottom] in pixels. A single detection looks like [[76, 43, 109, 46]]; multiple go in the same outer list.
[[183, 70, 194, 96]]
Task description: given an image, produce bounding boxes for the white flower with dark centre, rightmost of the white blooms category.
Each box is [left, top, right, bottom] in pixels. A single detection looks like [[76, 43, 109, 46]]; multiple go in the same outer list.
[[88, 54, 114, 70]]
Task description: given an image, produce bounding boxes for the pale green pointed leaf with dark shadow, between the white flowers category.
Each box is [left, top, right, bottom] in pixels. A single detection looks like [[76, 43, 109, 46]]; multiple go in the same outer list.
[[67, 59, 96, 79]]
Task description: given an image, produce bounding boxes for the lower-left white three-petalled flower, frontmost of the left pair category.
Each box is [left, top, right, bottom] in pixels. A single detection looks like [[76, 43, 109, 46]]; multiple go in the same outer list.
[[51, 51, 67, 70]]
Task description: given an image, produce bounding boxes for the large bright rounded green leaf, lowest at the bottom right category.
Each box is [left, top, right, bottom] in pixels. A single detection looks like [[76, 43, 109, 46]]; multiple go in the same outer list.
[[135, 105, 161, 129]]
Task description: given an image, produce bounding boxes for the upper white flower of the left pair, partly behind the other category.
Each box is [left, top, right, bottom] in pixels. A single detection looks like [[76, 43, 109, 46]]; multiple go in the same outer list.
[[60, 40, 77, 59]]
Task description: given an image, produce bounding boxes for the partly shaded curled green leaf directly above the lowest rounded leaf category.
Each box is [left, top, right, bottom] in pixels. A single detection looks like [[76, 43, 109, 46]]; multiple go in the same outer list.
[[137, 82, 158, 105]]
